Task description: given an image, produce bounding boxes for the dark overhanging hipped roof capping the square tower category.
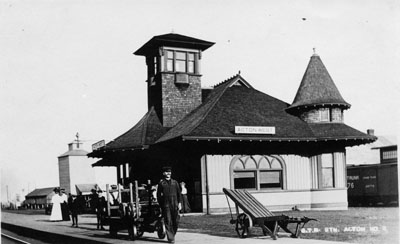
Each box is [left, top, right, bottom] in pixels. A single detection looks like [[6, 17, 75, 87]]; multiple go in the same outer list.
[[134, 33, 215, 56]]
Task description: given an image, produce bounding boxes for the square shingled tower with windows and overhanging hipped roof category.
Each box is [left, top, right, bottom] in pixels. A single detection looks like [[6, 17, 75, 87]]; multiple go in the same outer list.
[[134, 33, 214, 127]]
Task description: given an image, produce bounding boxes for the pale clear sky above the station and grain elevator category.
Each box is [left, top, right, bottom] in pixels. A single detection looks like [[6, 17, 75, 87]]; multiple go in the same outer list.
[[0, 0, 400, 201]]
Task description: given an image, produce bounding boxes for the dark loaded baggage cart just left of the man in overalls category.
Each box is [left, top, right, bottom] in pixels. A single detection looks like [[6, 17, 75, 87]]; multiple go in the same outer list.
[[106, 181, 166, 240]]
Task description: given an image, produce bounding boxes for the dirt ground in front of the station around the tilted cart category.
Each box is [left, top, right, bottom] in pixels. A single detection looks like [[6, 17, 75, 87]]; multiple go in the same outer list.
[[180, 207, 399, 244]]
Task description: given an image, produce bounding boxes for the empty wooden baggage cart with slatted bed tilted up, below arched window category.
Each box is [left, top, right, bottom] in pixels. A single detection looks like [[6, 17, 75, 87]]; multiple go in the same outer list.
[[222, 188, 317, 240]]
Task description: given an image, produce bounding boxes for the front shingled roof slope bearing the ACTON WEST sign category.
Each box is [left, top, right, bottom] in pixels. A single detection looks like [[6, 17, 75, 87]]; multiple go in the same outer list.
[[157, 75, 375, 143]]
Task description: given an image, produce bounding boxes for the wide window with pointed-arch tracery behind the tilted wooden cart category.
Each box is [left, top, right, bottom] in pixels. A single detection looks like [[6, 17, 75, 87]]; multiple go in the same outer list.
[[230, 155, 286, 190]]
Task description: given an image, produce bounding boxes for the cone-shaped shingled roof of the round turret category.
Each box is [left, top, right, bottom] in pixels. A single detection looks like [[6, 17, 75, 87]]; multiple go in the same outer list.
[[288, 54, 350, 110]]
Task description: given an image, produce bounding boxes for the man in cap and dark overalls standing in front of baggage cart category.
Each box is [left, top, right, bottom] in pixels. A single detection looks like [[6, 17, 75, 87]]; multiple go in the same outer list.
[[157, 166, 182, 243]]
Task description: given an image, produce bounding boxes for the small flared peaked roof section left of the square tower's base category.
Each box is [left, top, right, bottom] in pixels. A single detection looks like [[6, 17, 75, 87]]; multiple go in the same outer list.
[[99, 107, 166, 151]]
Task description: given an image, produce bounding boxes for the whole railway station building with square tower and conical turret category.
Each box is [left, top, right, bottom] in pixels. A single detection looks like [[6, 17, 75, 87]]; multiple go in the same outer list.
[[88, 34, 376, 213]]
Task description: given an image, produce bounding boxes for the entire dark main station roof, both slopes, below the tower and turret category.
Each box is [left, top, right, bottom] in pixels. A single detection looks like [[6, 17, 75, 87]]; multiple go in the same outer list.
[[88, 74, 376, 162]]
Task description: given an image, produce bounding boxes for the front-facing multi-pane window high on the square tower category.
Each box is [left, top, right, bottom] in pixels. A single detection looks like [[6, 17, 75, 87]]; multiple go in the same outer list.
[[165, 50, 195, 73]]
